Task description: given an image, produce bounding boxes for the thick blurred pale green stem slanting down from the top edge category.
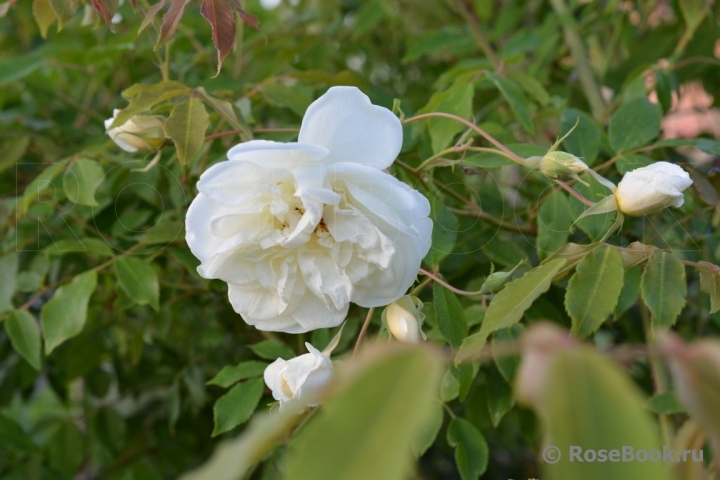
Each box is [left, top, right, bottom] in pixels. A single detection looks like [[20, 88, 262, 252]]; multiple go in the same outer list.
[[550, 0, 605, 119]]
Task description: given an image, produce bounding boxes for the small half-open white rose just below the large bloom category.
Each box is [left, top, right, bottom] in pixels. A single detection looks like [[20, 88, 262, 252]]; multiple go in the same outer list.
[[263, 343, 335, 410]]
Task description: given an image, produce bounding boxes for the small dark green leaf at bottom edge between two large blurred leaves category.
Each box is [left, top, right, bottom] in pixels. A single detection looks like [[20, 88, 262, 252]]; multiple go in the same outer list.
[[447, 417, 489, 480]]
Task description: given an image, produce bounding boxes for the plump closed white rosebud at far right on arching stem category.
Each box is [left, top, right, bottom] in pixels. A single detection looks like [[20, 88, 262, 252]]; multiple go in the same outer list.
[[615, 162, 692, 217]]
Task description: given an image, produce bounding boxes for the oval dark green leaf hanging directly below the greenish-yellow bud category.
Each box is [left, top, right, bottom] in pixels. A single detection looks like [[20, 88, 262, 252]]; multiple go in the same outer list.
[[536, 191, 573, 260]]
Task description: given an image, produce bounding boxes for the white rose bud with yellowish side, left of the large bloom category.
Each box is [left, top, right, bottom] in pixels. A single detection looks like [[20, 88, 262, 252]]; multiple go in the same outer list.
[[105, 110, 165, 153]]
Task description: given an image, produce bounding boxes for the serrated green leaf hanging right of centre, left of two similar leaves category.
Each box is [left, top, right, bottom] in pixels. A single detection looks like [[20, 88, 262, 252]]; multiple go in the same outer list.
[[565, 245, 625, 337]]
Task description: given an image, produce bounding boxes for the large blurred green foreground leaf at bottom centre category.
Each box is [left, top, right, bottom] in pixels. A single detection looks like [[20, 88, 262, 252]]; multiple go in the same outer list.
[[285, 343, 443, 480]]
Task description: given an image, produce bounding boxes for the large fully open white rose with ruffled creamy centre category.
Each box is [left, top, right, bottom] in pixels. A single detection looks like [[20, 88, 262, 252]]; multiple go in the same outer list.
[[186, 87, 432, 333]]
